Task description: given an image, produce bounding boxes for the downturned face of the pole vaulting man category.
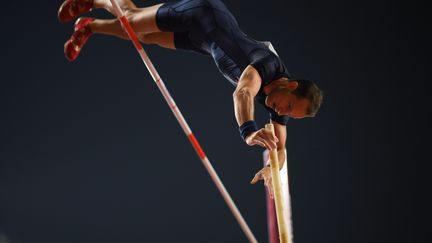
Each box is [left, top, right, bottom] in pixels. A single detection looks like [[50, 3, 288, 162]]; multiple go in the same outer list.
[[266, 89, 310, 119]]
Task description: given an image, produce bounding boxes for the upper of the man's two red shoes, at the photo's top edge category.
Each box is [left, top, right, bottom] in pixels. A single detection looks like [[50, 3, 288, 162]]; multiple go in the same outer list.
[[58, 0, 94, 23]]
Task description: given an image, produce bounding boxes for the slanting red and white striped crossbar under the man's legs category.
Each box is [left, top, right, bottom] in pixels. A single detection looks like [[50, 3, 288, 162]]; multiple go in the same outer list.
[[110, 0, 258, 243]]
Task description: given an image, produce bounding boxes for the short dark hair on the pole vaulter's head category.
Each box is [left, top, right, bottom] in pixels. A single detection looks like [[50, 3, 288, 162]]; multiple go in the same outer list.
[[289, 79, 323, 117]]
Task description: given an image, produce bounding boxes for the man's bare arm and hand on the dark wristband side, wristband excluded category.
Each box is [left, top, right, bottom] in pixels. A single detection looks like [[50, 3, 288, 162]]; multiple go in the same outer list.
[[233, 65, 278, 150]]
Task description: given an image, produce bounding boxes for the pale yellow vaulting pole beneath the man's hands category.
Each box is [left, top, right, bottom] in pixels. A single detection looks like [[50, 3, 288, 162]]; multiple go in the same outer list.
[[265, 123, 290, 243]]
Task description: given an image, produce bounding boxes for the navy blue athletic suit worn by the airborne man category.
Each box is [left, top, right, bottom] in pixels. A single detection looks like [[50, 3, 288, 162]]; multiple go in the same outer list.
[[156, 0, 291, 125]]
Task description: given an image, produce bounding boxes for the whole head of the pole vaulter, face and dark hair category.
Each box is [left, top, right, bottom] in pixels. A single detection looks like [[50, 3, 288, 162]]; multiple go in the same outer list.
[[266, 79, 322, 119]]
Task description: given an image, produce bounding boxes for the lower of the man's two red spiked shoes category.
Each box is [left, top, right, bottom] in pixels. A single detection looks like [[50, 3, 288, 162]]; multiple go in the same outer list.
[[64, 18, 94, 61]]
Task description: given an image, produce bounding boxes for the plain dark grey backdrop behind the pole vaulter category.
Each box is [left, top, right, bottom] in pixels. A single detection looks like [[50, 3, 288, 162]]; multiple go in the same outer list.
[[0, 0, 430, 243]]
